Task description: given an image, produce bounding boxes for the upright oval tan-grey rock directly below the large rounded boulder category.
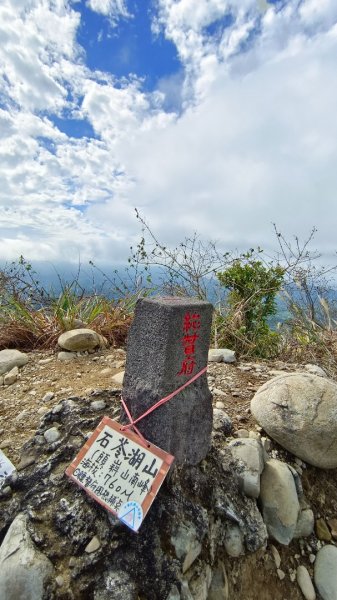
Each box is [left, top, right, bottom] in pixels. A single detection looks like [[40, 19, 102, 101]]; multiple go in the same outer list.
[[260, 459, 300, 545]]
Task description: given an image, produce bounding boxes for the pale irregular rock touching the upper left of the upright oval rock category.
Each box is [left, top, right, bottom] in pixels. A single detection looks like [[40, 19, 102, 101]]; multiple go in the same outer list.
[[228, 438, 264, 498]]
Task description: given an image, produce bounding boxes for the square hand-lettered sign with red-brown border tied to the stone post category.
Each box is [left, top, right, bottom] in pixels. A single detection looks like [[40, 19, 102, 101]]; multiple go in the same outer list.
[[66, 417, 174, 531]]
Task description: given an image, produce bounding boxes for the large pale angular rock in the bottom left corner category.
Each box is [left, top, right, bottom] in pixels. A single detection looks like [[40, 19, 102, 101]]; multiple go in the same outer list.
[[0, 513, 53, 600]]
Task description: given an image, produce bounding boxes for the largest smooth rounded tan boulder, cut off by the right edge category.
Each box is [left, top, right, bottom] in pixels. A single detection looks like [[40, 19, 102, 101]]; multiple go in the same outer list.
[[251, 373, 337, 469]]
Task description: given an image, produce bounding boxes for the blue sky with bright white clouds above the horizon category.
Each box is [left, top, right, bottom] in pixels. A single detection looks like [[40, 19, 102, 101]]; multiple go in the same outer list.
[[0, 0, 337, 272]]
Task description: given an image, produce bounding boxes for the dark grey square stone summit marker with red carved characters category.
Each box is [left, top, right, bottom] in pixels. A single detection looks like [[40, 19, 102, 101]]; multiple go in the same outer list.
[[122, 297, 213, 465]]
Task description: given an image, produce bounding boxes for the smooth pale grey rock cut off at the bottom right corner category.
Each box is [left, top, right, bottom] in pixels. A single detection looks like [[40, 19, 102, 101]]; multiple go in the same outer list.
[[314, 544, 337, 600]]
